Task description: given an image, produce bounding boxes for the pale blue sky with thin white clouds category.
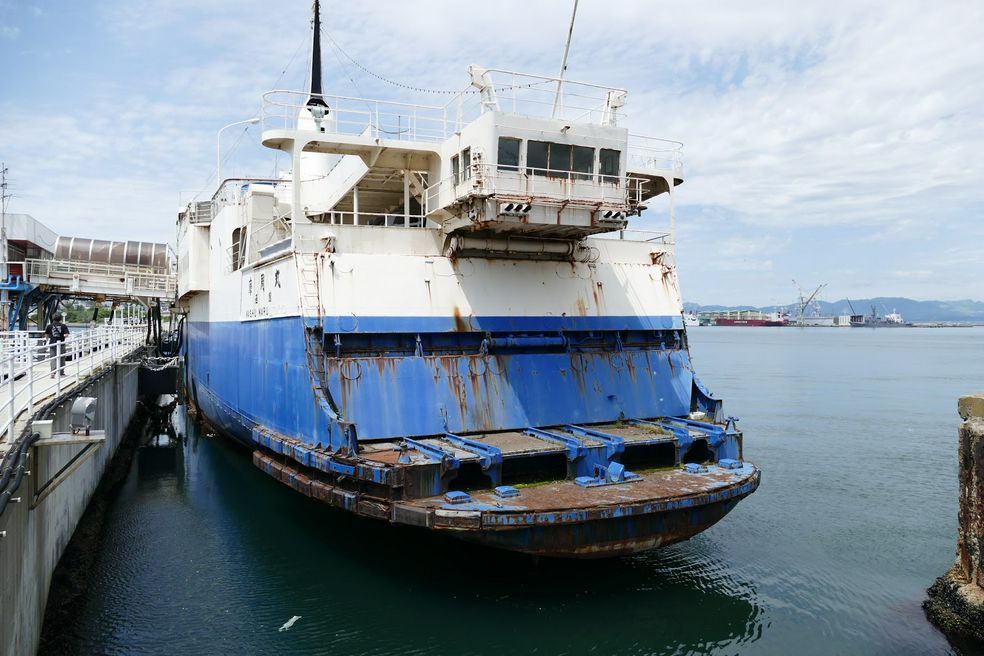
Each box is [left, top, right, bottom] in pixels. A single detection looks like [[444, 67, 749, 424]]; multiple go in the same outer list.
[[0, 0, 984, 305]]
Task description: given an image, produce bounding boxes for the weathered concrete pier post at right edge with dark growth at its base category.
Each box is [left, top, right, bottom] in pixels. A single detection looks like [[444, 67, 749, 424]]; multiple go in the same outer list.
[[923, 393, 984, 645]]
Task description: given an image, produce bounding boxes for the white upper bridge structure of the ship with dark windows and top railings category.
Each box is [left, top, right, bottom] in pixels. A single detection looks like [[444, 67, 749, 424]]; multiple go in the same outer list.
[[263, 66, 683, 239]]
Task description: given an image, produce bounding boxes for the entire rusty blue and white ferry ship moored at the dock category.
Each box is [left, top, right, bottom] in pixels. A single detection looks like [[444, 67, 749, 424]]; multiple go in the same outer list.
[[178, 4, 759, 557]]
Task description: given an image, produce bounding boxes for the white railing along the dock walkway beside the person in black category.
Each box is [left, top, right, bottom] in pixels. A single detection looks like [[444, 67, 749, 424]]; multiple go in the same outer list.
[[0, 325, 146, 442]]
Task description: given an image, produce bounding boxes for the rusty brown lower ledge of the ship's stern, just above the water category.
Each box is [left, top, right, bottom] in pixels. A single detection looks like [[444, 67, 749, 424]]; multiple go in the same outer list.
[[253, 450, 760, 558]]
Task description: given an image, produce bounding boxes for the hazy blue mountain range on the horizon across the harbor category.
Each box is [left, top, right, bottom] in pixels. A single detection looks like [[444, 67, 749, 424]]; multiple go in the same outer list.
[[683, 296, 984, 322]]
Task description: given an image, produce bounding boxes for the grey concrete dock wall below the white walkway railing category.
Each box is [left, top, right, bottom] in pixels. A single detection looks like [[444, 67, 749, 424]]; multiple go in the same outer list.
[[0, 365, 138, 656]]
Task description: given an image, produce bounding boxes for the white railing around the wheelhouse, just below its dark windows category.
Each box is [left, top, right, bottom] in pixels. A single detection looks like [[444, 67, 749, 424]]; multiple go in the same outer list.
[[424, 164, 647, 214]]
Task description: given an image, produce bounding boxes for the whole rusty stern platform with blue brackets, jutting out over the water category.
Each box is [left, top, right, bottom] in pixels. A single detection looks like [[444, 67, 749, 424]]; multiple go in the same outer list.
[[240, 412, 760, 558]]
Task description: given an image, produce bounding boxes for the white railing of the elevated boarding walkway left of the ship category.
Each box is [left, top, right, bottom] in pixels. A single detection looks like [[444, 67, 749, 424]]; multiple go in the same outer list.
[[25, 259, 177, 297]]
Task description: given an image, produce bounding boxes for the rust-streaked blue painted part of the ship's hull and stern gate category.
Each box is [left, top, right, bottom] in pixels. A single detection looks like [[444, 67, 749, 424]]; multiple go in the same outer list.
[[187, 317, 693, 451]]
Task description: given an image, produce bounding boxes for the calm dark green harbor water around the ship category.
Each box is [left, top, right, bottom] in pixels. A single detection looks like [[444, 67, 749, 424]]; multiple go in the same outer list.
[[38, 328, 984, 656]]
